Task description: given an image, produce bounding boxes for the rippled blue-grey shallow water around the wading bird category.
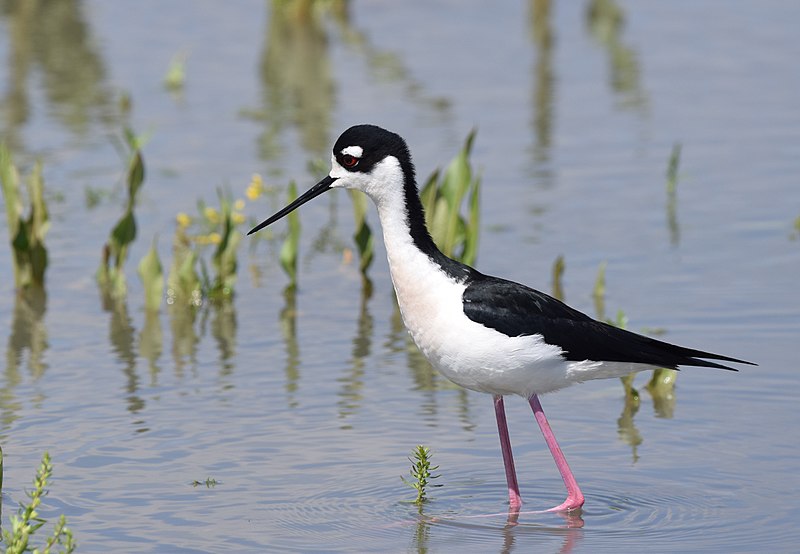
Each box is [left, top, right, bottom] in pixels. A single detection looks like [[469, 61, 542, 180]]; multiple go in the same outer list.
[[0, 2, 800, 552]]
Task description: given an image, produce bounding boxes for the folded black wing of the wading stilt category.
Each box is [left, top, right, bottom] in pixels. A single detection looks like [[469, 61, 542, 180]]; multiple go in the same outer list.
[[463, 275, 755, 371]]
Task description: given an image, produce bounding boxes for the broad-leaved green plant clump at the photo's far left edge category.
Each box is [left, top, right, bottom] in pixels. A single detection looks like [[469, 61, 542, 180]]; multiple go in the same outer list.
[[0, 143, 50, 290]]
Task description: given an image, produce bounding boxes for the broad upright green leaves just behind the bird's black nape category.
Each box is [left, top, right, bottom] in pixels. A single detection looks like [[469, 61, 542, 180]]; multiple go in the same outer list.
[[420, 130, 481, 264]]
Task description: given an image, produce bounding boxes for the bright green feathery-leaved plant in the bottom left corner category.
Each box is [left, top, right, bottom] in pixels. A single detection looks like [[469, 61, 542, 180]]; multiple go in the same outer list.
[[3, 452, 76, 554]]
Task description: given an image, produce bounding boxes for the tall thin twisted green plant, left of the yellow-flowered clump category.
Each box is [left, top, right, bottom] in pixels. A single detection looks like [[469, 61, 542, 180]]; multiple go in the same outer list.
[[97, 129, 145, 298]]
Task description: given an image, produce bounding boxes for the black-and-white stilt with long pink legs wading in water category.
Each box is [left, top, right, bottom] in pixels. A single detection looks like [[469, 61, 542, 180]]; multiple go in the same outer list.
[[248, 125, 753, 511]]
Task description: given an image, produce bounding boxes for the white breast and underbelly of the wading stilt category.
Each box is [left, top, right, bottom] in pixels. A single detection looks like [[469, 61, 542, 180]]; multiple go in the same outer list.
[[378, 198, 648, 398]]
